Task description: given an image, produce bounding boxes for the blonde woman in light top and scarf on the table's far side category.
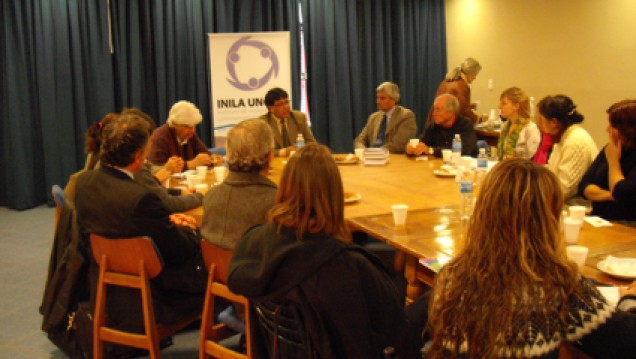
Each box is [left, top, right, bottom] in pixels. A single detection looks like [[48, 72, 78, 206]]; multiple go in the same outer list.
[[497, 87, 541, 159]]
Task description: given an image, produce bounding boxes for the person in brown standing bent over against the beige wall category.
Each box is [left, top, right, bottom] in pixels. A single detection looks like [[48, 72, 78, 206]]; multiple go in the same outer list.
[[426, 57, 481, 127]]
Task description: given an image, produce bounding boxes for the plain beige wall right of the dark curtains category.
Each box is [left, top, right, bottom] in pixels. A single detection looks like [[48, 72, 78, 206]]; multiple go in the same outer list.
[[446, 0, 636, 149]]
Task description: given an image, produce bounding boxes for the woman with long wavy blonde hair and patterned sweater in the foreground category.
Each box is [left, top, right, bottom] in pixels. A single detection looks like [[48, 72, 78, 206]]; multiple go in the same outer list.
[[426, 158, 636, 358]]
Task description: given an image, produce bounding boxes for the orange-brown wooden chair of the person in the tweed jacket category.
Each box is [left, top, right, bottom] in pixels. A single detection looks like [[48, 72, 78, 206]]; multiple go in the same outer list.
[[199, 240, 252, 359]]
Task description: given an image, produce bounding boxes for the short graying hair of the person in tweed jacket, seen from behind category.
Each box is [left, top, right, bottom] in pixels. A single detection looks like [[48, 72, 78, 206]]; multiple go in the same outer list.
[[227, 119, 274, 172]]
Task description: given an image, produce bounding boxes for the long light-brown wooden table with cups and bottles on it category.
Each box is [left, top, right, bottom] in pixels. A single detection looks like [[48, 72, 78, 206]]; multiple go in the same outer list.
[[189, 155, 636, 300]]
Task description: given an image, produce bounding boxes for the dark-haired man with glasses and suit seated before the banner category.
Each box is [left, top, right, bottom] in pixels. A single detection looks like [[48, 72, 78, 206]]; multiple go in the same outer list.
[[259, 87, 316, 157]]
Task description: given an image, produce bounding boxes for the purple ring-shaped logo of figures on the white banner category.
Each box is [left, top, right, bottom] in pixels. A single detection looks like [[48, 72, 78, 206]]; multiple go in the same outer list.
[[225, 36, 278, 91]]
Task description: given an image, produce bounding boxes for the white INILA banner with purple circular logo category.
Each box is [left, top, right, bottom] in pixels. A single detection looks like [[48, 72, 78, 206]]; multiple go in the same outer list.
[[208, 31, 291, 136]]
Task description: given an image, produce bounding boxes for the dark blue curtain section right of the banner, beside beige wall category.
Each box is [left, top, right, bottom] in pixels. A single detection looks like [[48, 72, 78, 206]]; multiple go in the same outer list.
[[301, 0, 446, 152]]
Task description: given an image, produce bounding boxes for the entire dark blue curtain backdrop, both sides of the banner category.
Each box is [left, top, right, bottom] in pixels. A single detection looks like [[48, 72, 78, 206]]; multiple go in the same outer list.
[[0, 0, 446, 209]]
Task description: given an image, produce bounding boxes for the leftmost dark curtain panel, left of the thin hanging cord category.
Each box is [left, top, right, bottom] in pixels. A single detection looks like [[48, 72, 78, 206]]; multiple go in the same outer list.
[[0, 0, 115, 209]]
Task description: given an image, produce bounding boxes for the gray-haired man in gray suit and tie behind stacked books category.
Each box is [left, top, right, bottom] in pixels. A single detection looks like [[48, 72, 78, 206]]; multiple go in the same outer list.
[[353, 82, 417, 153]]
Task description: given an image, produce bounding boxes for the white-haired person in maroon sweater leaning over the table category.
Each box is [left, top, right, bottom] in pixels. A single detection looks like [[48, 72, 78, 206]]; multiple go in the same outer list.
[[148, 101, 223, 170]]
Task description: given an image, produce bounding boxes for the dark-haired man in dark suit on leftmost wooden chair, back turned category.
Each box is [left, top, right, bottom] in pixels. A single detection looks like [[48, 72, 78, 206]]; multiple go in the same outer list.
[[75, 112, 207, 338]]
